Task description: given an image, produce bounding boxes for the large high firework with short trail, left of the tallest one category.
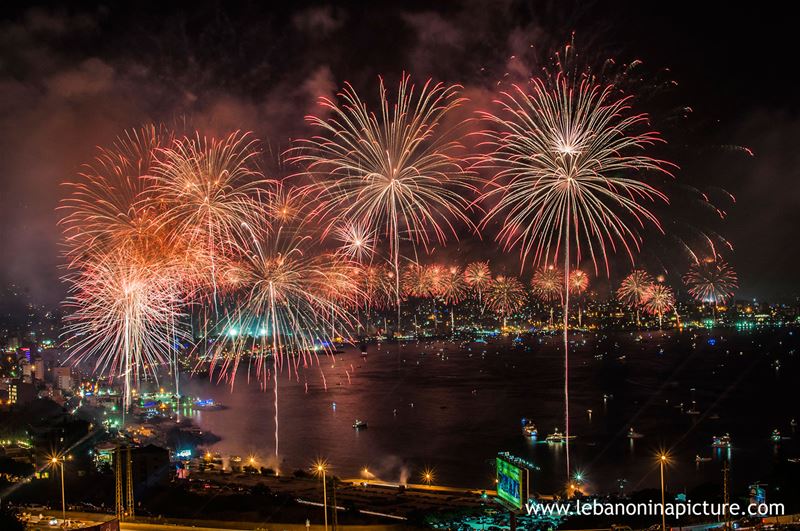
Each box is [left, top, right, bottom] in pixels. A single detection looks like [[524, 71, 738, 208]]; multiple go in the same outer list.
[[290, 75, 474, 330]]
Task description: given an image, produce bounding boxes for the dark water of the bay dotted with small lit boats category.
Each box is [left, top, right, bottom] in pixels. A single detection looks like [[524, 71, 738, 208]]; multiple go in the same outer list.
[[184, 331, 800, 492]]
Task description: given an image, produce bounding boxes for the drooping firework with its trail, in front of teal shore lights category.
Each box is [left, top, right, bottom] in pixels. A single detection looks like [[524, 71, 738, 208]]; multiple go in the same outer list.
[[211, 221, 356, 456]]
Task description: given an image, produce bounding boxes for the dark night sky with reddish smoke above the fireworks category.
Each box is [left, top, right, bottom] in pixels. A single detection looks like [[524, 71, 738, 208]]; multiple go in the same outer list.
[[0, 1, 800, 304]]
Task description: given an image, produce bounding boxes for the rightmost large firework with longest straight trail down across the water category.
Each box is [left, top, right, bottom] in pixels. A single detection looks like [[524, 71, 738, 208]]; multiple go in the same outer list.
[[479, 72, 668, 478]]
